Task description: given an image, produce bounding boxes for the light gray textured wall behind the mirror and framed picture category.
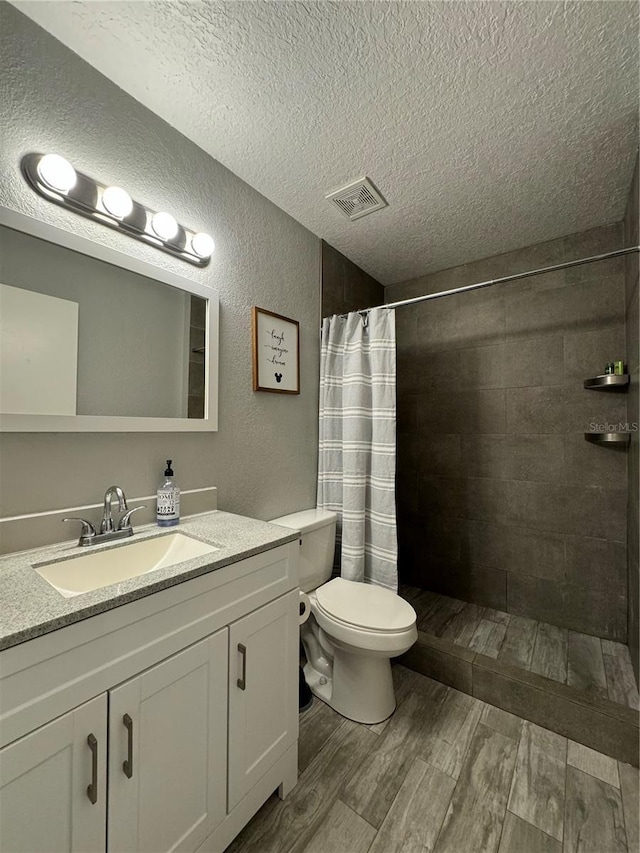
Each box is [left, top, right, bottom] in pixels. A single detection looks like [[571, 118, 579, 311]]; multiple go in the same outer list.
[[0, 3, 320, 524]]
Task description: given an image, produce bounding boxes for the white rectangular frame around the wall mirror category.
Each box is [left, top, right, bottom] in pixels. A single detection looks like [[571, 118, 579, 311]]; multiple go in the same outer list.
[[0, 205, 219, 432]]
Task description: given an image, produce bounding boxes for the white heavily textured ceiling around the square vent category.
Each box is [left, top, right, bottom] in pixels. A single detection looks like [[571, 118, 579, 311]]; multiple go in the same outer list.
[[14, 0, 638, 284]]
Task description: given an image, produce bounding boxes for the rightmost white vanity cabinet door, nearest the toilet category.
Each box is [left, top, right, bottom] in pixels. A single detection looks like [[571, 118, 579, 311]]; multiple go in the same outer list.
[[229, 590, 300, 811]]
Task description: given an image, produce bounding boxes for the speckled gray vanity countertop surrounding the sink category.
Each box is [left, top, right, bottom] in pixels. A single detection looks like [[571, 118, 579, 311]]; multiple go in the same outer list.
[[0, 511, 298, 651]]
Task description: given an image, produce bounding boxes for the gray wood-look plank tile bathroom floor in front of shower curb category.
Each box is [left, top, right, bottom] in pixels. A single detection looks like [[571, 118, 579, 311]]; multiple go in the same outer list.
[[228, 665, 639, 853]]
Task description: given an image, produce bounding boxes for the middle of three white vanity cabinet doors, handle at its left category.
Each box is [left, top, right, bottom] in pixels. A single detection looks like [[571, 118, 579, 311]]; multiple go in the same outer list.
[[108, 628, 228, 853]]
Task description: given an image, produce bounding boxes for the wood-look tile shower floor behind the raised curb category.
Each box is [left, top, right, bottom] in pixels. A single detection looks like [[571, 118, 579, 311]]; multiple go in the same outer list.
[[399, 585, 640, 710]]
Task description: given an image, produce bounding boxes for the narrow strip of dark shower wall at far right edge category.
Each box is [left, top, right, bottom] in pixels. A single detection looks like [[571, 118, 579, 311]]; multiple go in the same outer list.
[[624, 153, 640, 683]]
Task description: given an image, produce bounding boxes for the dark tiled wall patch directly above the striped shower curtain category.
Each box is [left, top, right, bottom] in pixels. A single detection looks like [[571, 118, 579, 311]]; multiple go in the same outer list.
[[322, 240, 384, 317]]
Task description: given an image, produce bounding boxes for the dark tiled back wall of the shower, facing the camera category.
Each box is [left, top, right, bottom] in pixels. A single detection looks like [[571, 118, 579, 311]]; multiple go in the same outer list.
[[386, 223, 627, 640]]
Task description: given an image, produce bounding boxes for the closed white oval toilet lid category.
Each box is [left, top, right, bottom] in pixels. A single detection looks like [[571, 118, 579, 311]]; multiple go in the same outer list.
[[316, 578, 416, 631]]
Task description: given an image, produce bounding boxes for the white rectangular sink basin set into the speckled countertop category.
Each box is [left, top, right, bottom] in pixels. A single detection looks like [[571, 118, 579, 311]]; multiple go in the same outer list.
[[34, 533, 220, 598]]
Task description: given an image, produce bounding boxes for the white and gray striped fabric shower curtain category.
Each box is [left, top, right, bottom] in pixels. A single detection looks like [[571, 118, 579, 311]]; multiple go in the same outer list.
[[317, 308, 398, 592]]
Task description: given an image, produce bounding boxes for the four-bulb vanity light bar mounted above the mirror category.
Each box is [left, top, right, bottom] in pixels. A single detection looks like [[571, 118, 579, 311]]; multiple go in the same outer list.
[[21, 154, 215, 267]]
